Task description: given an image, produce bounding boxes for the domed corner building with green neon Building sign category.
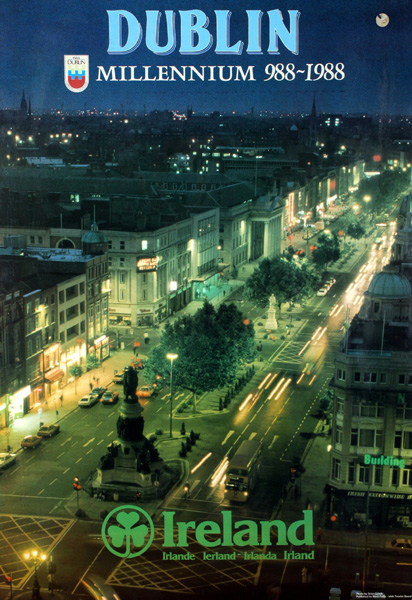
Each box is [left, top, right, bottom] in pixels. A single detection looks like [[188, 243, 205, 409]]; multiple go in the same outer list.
[[327, 199, 412, 527]]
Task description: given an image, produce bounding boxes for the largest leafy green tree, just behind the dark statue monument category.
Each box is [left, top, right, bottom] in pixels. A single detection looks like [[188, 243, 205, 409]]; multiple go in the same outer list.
[[145, 302, 255, 412]]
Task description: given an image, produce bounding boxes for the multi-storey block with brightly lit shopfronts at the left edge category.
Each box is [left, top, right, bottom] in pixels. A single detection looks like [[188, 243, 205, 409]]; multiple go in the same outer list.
[[0, 227, 110, 426]]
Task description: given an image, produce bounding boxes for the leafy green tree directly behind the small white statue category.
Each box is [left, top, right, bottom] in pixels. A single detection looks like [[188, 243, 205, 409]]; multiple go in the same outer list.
[[244, 257, 319, 310]]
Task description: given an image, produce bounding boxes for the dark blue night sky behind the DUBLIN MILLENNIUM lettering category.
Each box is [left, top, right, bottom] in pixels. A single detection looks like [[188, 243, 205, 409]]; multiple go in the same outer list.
[[0, 0, 412, 114]]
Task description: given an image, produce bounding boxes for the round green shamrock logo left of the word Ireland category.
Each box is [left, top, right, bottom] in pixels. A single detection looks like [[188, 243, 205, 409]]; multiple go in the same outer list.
[[102, 505, 154, 558]]
